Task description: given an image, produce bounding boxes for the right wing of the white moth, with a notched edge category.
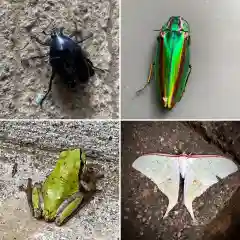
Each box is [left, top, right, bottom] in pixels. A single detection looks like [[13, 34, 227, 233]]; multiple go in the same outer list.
[[184, 156, 238, 222]]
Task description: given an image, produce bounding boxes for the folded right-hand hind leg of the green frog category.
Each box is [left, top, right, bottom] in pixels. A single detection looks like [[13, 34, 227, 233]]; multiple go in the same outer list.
[[55, 192, 86, 226]]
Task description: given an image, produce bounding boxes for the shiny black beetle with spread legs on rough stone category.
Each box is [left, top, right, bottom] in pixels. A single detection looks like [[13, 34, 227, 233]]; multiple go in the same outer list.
[[31, 28, 103, 106]]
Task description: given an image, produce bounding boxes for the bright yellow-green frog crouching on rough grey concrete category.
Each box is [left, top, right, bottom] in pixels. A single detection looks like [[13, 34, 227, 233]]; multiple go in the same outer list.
[[20, 149, 103, 226]]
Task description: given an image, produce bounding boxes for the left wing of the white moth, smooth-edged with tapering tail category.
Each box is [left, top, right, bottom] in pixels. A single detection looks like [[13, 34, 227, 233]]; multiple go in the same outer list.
[[132, 154, 180, 218]]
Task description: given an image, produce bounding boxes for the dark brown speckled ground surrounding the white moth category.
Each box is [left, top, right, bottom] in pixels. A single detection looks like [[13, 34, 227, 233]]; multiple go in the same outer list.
[[121, 122, 240, 240]]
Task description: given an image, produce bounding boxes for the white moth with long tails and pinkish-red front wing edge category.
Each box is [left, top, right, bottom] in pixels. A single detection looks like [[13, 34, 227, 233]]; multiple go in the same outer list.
[[132, 153, 238, 223]]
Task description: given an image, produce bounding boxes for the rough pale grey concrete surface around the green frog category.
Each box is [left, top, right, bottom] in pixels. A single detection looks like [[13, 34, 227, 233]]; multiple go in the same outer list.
[[0, 121, 120, 240]]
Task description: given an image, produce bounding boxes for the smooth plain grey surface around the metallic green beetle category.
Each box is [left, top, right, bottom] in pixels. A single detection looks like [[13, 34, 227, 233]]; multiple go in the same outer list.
[[121, 0, 240, 119]]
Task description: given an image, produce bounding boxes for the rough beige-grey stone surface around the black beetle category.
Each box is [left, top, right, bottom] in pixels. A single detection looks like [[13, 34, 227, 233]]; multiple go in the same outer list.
[[0, 0, 119, 119]]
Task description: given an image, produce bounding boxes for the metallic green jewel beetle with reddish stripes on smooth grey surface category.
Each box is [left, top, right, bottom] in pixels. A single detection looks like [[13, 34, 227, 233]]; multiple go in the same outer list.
[[137, 16, 192, 110]]
